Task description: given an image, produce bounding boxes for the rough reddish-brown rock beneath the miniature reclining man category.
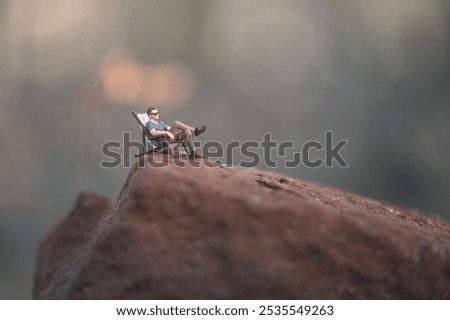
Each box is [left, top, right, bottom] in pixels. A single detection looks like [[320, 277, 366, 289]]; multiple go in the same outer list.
[[34, 154, 450, 299]]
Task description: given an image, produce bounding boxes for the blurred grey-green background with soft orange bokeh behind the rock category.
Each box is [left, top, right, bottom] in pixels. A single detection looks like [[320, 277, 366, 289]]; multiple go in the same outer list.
[[0, 0, 450, 299]]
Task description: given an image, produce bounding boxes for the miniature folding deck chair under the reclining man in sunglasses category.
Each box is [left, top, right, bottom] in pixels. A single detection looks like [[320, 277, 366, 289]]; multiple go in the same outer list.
[[132, 111, 189, 157]]
